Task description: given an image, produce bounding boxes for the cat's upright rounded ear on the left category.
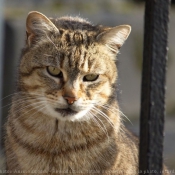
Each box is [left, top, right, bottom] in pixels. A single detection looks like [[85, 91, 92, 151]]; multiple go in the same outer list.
[[26, 11, 59, 46]]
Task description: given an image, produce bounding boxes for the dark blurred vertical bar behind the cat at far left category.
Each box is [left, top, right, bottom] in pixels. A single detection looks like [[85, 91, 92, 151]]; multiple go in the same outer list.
[[1, 20, 16, 148]]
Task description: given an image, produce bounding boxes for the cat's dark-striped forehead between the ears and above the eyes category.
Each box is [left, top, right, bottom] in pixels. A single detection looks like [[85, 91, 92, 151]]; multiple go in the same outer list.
[[45, 29, 109, 72]]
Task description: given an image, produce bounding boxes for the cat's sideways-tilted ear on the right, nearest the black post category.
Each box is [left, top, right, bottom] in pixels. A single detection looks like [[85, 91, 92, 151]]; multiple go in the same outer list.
[[97, 25, 131, 53]]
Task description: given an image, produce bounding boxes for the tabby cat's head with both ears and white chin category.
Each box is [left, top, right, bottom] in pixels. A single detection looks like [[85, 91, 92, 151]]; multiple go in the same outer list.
[[19, 12, 131, 121]]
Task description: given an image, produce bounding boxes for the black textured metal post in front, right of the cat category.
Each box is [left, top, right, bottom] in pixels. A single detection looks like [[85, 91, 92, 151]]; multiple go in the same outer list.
[[139, 0, 170, 175]]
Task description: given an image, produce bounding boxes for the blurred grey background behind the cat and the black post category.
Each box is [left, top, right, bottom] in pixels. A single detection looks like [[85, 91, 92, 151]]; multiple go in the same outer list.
[[0, 0, 175, 173]]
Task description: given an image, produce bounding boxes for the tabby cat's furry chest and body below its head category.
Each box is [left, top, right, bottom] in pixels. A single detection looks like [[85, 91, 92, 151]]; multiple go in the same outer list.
[[7, 98, 138, 175]]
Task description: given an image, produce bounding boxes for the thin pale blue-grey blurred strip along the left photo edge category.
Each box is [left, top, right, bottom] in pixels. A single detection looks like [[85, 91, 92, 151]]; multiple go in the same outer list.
[[0, 0, 4, 150]]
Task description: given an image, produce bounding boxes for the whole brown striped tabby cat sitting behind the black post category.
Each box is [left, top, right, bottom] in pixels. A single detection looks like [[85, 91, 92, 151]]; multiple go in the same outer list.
[[5, 11, 168, 175]]
